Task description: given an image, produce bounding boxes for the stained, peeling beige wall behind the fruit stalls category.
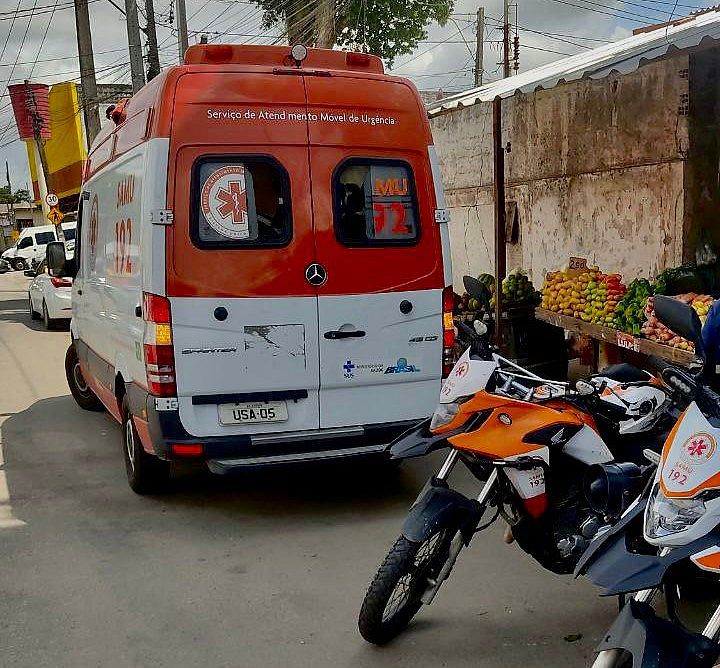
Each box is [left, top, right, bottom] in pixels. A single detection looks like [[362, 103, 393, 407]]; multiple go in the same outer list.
[[432, 54, 688, 286]]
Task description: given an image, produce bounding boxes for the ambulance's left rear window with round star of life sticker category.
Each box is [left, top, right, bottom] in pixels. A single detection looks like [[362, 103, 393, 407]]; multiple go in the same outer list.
[[190, 156, 292, 249]]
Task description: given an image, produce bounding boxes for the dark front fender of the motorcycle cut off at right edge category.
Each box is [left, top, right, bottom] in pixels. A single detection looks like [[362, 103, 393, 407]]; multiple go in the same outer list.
[[597, 600, 720, 668]]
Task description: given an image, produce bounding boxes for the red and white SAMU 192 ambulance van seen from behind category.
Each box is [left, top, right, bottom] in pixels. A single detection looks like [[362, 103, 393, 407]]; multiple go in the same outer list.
[[48, 44, 454, 493]]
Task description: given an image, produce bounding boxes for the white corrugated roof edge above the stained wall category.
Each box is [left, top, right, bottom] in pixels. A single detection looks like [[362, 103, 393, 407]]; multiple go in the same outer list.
[[427, 11, 720, 116]]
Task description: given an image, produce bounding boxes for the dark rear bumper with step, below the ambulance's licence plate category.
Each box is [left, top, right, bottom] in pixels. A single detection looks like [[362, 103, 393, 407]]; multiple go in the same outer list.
[[135, 388, 415, 474]]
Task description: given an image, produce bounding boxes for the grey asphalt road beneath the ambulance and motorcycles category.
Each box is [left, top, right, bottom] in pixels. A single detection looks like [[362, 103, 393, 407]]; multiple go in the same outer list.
[[0, 273, 615, 668]]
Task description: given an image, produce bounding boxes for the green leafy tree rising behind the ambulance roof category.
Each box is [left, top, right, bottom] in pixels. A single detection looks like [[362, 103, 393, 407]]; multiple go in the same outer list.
[[255, 0, 454, 67]]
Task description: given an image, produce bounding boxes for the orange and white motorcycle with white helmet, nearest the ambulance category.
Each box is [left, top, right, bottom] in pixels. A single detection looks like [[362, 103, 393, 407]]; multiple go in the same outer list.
[[358, 312, 672, 644]]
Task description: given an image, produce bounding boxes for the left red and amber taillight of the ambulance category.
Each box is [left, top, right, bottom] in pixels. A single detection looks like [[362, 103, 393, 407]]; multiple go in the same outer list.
[[143, 292, 177, 397]]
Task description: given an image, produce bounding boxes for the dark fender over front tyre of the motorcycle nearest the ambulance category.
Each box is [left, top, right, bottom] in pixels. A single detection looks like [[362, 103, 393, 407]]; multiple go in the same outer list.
[[402, 479, 483, 543]]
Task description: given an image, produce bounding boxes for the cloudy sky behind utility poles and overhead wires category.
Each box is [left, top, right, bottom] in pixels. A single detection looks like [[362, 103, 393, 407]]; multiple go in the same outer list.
[[0, 0, 711, 188]]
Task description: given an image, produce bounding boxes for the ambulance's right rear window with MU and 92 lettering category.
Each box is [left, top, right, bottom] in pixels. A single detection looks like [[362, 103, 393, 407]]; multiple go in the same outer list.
[[333, 158, 419, 246]]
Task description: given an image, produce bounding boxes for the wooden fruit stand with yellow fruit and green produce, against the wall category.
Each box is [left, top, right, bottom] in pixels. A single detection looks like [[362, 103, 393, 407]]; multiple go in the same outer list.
[[535, 258, 718, 367]]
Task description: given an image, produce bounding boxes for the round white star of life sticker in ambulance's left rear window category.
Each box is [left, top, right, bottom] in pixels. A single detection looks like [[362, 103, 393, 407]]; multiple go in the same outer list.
[[200, 165, 250, 239]]
